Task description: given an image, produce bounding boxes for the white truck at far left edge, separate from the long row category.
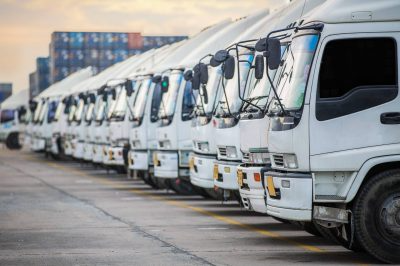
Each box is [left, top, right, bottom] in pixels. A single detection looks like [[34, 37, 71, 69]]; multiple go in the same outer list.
[[0, 90, 29, 149]]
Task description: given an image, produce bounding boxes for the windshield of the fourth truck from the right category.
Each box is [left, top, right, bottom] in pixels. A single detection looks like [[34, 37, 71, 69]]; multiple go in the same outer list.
[[196, 66, 222, 115]]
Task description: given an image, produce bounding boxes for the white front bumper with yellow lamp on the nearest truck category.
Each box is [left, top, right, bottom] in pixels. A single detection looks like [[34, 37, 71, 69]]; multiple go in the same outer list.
[[264, 171, 313, 221]]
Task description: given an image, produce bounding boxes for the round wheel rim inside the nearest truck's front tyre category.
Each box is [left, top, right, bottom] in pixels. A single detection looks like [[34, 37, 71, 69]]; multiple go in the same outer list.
[[378, 194, 400, 246]]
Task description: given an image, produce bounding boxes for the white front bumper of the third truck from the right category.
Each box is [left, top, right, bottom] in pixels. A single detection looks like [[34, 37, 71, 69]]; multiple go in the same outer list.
[[213, 161, 239, 190]]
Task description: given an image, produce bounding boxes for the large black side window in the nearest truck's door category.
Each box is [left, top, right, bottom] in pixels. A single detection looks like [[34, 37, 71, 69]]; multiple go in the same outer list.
[[316, 38, 398, 121]]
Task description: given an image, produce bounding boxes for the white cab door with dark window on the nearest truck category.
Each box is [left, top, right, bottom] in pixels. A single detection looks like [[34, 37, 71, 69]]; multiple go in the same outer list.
[[310, 33, 400, 171]]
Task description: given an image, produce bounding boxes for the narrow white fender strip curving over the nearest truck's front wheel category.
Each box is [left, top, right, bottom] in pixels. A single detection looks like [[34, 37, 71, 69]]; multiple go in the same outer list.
[[346, 155, 400, 203]]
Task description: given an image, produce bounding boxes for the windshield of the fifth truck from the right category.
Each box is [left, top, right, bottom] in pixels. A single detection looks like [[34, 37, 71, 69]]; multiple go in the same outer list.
[[160, 71, 183, 117]]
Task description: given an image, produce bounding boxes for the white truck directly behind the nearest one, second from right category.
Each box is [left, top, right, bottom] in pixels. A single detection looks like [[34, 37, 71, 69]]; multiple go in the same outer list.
[[237, 0, 325, 213]]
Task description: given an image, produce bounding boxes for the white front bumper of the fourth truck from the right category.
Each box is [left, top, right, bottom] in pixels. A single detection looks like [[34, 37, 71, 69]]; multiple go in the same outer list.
[[190, 154, 216, 188]]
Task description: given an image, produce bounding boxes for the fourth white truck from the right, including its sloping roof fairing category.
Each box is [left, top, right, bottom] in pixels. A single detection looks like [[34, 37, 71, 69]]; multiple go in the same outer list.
[[190, 11, 268, 194]]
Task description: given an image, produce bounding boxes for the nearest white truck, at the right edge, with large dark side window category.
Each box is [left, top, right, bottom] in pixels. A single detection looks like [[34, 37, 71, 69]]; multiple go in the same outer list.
[[256, 0, 400, 263]]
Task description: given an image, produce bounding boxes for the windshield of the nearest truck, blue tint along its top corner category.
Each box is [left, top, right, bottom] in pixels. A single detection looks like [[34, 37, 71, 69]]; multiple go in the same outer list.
[[270, 34, 319, 112]]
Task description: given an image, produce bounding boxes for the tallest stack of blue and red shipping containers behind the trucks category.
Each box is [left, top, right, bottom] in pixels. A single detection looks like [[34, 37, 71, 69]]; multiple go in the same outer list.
[[50, 32, 187, 83]]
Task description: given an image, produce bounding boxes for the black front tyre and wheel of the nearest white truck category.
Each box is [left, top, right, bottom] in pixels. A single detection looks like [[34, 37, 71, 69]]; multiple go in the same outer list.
[[353, 170, 400, 263]]
